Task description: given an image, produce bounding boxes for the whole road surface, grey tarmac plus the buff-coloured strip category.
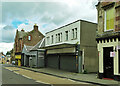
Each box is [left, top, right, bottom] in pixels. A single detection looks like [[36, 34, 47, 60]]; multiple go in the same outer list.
[[2, 65, 95, 86]]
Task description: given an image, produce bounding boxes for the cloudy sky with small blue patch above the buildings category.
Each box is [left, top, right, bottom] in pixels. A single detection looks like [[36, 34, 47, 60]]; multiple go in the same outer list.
[[0, 0, 98, 54]]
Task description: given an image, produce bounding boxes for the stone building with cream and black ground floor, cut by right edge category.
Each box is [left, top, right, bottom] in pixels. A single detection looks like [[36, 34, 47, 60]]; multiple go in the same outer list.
[[96, 0, 120, 80]]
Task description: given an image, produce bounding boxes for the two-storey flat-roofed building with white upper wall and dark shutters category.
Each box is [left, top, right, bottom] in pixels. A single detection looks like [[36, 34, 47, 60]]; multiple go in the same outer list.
[[45, 20, 98, 72]]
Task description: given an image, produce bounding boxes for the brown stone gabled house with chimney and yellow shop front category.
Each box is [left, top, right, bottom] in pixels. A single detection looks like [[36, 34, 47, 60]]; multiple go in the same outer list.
[[14, 24, 44, 66]]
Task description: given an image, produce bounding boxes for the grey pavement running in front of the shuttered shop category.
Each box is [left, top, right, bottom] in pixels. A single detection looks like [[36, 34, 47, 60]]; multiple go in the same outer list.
[[3, 63, 120, 86]]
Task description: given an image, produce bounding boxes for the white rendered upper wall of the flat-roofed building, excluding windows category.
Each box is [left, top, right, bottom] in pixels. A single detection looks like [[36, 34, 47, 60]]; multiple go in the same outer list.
[[45, 21, 80, 46]]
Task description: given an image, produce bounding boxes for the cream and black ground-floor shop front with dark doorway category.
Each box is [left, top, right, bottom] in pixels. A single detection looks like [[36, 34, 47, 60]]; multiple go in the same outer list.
[[97, 37, 120, 80]]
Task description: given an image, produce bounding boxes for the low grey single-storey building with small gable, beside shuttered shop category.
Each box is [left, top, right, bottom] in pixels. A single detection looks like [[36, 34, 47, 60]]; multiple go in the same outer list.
[[22, 38, 45, 68]]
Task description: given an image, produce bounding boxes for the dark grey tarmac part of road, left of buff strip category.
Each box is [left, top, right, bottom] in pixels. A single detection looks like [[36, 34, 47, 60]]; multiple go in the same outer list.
[[0, 64, 51, 86]]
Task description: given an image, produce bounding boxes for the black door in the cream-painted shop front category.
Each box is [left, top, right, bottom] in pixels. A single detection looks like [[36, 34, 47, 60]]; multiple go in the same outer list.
[[103, 47, 114, 78]]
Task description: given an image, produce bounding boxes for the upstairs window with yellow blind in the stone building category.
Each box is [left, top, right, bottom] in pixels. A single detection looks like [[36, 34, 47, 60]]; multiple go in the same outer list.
[[105, 7, 115, 31]]
